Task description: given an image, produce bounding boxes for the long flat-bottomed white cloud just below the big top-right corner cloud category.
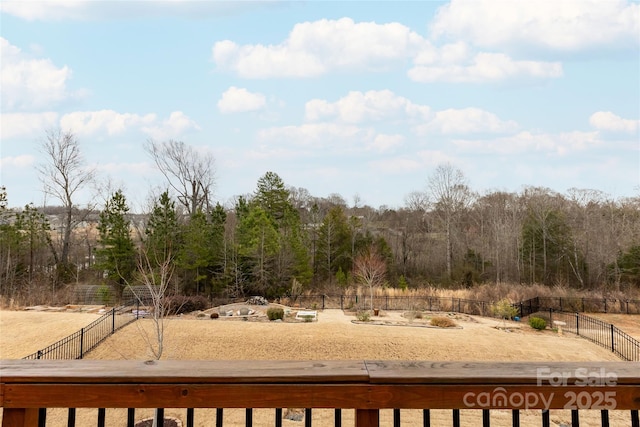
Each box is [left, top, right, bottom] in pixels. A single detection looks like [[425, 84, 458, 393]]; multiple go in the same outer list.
[[407, 52, 563, 83]]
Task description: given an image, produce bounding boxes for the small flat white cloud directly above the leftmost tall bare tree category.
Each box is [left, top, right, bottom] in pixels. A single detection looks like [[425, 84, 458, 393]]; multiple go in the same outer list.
[[60, 110, 156, 135]]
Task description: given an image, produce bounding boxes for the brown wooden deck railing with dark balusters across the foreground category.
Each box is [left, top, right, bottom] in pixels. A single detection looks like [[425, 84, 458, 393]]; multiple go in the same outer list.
[[0, 360, 640, 427]]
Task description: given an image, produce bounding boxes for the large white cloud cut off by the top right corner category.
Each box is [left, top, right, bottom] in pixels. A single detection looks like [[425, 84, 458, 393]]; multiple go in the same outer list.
[[430, 0, 640, 51]]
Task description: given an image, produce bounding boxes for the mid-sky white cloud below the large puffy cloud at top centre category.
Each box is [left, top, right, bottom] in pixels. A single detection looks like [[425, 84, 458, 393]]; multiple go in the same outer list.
[[305, 90, 430, 123]]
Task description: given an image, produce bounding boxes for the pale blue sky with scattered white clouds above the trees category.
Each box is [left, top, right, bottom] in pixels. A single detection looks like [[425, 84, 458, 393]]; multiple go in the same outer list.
[[0, 0, 640, 211]]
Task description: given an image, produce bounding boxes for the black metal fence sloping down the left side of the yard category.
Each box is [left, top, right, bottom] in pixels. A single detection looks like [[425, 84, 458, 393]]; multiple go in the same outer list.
[[23, 305, 139, 359]]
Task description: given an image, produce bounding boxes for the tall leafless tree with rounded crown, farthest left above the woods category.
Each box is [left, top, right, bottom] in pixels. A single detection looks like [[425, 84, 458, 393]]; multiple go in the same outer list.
[[38, 129, 95, 280]]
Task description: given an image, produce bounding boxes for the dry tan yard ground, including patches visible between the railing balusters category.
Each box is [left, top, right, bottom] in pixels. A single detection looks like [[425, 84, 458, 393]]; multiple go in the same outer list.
[[0, 310, 630, 427]]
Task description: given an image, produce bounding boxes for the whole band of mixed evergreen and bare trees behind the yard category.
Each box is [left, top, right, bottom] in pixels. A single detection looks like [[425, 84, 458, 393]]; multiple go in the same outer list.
[[0, 131, 640, 304]]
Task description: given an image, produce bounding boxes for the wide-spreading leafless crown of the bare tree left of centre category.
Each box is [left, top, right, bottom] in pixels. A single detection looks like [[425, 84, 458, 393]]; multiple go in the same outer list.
[[144, 139, 215, 215]]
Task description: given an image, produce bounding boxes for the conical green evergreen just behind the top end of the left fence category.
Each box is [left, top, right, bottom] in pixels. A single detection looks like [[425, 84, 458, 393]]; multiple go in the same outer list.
[[96, 190, 136, 296]]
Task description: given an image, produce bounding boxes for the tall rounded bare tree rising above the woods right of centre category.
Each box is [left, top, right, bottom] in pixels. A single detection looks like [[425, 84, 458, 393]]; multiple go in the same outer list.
[[428, 163, 471, 279]]
